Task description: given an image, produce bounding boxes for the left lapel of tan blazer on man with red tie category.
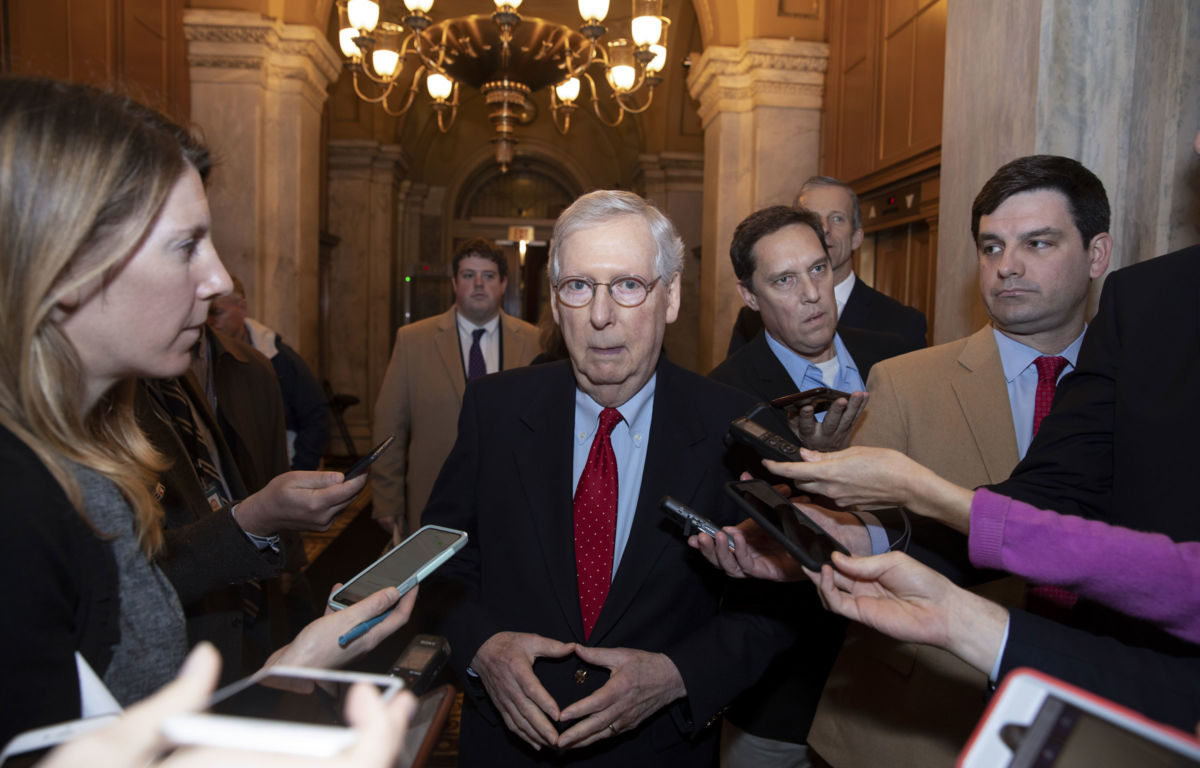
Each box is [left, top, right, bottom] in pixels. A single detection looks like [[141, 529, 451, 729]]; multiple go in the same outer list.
[[950, 325, 1018, 482]]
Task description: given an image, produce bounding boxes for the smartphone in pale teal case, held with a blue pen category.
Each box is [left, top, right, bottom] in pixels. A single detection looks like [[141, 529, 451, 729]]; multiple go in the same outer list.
[[329, 526, 467, 611]]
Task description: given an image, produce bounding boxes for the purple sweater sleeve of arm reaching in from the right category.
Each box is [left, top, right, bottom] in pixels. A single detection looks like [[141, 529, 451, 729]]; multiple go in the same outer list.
[[967, 488, 1200, 642]]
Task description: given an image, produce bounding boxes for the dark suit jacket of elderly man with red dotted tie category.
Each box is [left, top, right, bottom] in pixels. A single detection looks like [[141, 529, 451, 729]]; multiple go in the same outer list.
[[422, 359, 791, 768]]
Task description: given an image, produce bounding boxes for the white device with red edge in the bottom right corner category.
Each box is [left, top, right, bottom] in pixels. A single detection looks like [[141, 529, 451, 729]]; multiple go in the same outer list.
[[958, 668, 1200, 768]]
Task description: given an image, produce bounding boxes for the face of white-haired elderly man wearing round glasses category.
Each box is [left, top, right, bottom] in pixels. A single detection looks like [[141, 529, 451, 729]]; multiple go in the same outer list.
[[551, 215, 679, 407]]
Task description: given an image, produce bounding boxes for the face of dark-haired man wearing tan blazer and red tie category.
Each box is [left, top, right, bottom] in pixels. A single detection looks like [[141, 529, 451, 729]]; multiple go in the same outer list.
[[977, 190, 1111, 346]]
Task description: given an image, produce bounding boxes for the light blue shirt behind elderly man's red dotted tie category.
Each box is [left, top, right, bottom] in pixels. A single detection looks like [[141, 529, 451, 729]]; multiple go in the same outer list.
[[571, 373, 659, 577]]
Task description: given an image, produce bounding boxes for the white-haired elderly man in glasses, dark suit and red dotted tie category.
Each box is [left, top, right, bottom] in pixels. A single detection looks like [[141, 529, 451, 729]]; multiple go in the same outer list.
[[422, 191, 791, 768]]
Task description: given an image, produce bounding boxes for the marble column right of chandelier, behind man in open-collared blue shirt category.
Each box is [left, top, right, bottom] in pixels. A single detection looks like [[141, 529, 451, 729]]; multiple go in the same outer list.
[[688, 40, 829, 371]]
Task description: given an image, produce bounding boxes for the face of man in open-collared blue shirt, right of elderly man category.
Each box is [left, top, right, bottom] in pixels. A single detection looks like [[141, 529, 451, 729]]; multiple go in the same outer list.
[[738, 224, 838, 362]]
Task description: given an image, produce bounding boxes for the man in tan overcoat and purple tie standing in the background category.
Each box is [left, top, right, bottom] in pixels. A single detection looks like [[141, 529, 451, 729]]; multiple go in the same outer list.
[[371, 239, 539, 536]]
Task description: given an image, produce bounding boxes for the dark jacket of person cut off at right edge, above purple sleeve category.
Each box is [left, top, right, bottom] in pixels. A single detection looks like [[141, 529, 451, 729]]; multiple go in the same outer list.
[[992, 246, 1200, 541]]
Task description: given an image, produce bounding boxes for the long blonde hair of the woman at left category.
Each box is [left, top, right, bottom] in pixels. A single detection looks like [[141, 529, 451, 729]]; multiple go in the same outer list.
[[0, 78, 208, 556]]
